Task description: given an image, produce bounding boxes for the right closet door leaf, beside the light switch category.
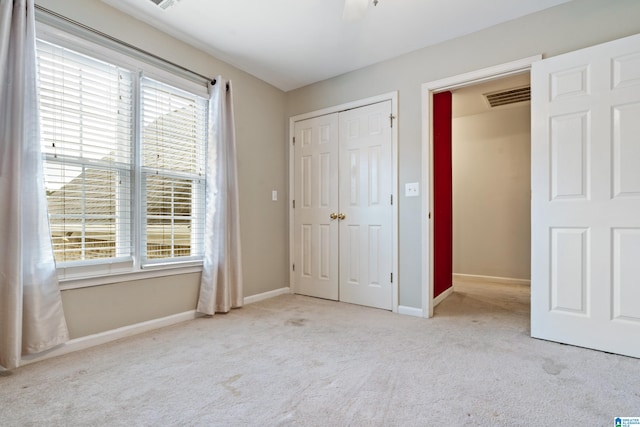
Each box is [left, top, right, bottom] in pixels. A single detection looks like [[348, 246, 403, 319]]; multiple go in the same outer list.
[[339, 101, 393, 310]]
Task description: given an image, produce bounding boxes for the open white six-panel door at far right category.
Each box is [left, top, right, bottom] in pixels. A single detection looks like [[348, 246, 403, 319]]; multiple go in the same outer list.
[[531, 35, 640, 357]]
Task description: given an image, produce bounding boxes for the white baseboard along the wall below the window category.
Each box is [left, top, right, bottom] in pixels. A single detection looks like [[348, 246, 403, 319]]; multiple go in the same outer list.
[[20, 287, 290, 366]]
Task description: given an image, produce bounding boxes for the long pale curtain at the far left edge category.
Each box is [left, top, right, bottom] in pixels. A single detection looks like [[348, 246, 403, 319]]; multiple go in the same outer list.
[[0, 0, 69, 369]]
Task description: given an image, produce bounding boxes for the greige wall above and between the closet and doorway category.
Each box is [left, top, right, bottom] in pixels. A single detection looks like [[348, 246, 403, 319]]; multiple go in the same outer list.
[[286, 0, 640, 307]]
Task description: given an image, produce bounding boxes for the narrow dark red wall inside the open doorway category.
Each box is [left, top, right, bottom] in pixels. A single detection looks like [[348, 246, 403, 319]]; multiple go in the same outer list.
[[433, 92, 453, 298]]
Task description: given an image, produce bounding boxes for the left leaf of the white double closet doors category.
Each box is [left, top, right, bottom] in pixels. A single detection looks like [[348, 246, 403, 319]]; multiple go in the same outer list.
[[293, 113, 339, 300]]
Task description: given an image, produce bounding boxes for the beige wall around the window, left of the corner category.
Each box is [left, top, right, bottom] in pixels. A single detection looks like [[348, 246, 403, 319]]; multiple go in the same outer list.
[[36, 0, 289, 338]]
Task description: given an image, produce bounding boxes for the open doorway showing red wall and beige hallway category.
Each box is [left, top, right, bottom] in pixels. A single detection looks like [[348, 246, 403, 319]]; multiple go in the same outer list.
[[433, 73, 531, 314]]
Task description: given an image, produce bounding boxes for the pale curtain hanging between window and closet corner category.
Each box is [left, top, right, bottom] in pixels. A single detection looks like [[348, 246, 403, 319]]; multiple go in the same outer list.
[[196, 76, 243, 315]]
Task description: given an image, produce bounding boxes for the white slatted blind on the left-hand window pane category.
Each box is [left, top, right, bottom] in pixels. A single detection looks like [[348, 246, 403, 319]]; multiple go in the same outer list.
[[37, 40, 134, 263]]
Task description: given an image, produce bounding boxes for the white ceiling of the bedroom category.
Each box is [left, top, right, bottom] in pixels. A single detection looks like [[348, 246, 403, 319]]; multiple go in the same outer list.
[[103, 0, 569, 91]]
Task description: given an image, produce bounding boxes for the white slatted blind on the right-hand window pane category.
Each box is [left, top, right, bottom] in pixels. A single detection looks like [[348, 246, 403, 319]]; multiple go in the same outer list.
[[140, 78, 207, 263]]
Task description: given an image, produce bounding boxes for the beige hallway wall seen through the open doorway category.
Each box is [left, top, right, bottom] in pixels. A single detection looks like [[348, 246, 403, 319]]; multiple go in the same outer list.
[[452, 105, 531, 280]]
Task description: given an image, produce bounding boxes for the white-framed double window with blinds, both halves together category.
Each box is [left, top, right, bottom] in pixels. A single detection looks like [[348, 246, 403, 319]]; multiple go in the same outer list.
[[37, 36, 207, 274]]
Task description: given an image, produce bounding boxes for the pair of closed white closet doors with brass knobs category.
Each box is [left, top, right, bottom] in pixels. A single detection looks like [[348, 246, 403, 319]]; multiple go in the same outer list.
[[294, 101, 393, 310]]
